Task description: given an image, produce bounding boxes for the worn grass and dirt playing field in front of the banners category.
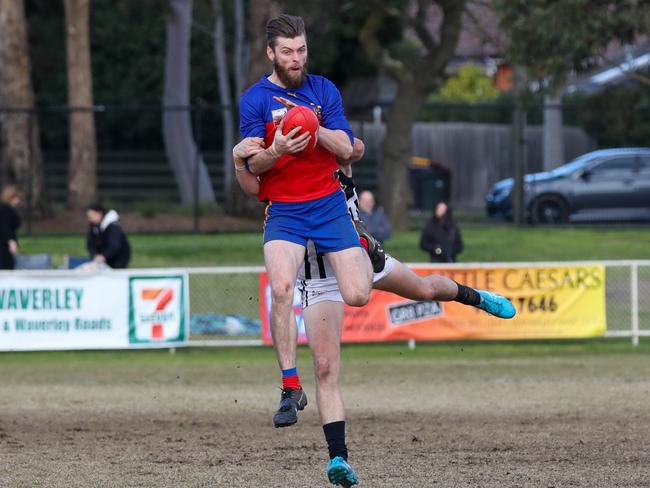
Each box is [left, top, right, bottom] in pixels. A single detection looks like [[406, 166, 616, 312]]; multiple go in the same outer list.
[[0, 341, 650, 488]]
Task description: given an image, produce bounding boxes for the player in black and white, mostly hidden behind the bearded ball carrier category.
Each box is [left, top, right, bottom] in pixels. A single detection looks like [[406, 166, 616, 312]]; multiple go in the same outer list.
[[233, 138, 515, 486]]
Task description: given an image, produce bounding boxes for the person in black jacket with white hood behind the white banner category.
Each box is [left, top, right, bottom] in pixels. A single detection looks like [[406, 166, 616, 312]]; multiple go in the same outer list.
[[86, 203, 131, 268]]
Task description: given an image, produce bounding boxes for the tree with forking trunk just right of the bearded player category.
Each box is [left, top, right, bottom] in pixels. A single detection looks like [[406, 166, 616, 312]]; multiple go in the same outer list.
[[358, 0, 466, 229]]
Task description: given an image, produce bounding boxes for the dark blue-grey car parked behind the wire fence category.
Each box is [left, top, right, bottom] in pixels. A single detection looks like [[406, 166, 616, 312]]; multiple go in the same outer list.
[[486, 148, 650, 224]]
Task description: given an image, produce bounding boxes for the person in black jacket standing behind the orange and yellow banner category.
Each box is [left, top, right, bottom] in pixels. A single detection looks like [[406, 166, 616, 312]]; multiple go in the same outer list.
[[420, 202, 463, 263]]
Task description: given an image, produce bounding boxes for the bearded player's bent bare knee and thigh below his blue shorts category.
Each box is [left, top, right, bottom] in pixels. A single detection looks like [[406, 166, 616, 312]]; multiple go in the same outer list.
[[326, 247, 373, 307]]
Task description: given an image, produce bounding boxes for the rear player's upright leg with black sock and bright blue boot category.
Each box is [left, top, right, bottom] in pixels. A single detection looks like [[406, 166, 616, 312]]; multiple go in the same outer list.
[[303, 301, 358, 487]]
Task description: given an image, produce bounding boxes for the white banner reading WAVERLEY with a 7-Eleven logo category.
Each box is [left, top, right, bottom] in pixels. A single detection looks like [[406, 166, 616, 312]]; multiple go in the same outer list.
[[0, 271, 189, 351]]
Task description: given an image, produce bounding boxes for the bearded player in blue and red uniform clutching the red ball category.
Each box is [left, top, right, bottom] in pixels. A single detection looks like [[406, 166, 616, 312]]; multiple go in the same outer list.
[[240, 15, 372, 427]]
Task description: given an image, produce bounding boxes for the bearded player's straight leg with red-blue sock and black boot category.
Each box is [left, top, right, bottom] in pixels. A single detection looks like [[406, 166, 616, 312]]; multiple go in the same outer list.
[[264, 240, 307, 427]]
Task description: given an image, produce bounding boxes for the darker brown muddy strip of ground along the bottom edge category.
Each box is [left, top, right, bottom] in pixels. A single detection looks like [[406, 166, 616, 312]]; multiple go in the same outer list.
[[0, 406, 650, 487]]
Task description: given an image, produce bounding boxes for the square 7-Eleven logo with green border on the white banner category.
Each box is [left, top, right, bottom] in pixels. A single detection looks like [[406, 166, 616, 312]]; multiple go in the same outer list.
[[129, 275, 188, 343]]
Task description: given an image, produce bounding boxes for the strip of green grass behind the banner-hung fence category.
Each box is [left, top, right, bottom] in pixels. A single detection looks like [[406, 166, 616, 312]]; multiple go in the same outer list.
[[20, 225, 650, 267]]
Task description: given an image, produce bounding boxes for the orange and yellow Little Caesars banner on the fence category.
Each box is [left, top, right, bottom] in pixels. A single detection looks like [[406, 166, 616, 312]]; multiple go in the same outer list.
[[260, 265, 607, 344]]
